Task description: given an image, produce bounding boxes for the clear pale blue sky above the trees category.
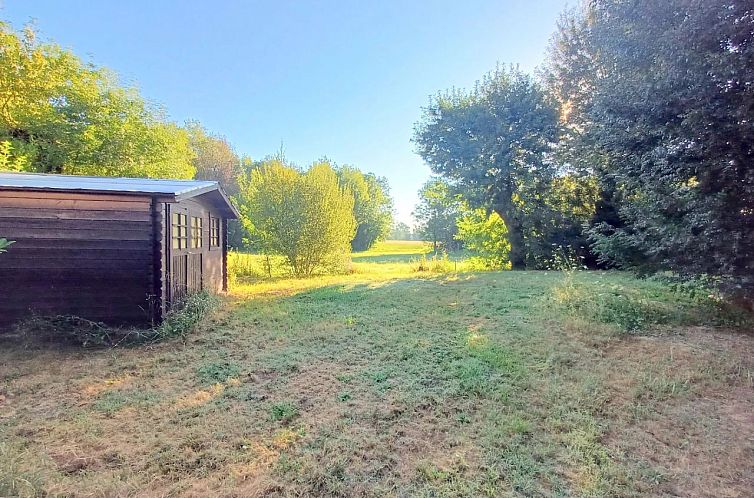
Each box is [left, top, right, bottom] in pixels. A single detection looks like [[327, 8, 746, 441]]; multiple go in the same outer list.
[[0, 0, 574, 222]]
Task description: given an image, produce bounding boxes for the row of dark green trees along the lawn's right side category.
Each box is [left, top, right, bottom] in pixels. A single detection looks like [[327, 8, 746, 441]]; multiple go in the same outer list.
[[414, 0, 754, 296]]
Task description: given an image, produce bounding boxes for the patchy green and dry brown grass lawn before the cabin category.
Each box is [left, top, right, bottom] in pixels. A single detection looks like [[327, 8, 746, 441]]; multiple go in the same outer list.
[[0, 240, 754, 497]]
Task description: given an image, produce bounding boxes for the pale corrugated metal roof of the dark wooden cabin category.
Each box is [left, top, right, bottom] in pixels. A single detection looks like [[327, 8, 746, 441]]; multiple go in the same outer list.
[[0, 173, 218, 197]]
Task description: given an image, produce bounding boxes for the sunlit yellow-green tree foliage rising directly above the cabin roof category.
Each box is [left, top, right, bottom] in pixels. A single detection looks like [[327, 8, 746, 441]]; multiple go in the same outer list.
[[0, 23, 194, 178]]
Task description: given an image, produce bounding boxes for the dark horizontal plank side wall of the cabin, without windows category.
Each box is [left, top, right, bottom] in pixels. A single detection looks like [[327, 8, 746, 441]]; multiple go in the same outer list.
[[0, 191, 154, 326]]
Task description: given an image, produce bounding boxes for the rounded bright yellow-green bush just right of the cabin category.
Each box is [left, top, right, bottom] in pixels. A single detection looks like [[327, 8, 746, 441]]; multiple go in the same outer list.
[[240, 159, 356, 276]]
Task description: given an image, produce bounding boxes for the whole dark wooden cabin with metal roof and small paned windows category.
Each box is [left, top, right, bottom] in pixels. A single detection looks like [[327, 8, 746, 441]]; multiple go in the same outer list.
[[0, 173, 238, 326]]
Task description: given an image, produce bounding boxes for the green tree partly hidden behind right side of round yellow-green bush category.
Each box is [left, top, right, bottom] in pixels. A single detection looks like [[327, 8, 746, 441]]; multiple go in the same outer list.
[[336, 166, 393, 251]]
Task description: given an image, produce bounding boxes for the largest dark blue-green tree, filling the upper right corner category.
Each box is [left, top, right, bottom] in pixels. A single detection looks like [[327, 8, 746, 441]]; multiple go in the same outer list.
[[549, 0, 754, 292]]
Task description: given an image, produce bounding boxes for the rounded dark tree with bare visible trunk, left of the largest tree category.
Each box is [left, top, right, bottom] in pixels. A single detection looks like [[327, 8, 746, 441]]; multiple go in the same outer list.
[[413, 69, 558, 269]]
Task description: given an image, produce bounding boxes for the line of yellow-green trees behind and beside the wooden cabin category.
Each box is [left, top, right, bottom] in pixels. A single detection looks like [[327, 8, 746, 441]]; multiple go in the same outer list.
[[0, 23, 393, 275]]
